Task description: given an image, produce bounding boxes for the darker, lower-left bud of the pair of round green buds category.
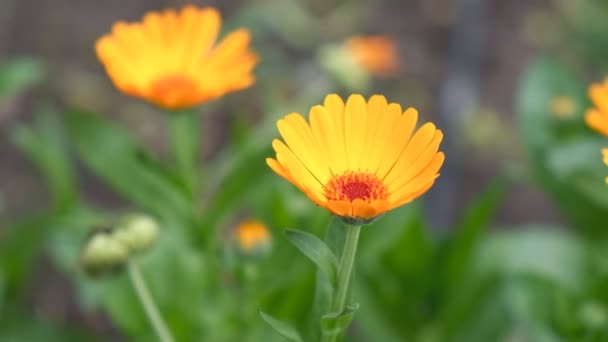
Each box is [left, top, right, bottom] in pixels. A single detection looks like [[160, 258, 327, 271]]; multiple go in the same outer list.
[[80, 231, 129, 277]]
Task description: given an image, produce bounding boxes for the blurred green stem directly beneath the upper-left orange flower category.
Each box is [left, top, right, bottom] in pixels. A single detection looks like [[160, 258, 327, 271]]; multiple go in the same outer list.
[[168, 110, 201, 197]]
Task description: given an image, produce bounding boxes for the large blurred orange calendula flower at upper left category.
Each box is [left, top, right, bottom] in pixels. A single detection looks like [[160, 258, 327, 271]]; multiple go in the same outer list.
[[95, 6, 257, 110]]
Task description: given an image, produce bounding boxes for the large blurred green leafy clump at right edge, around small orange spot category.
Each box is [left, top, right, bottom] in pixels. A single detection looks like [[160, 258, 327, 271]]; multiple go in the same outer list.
[[517, 58, 608, 236]]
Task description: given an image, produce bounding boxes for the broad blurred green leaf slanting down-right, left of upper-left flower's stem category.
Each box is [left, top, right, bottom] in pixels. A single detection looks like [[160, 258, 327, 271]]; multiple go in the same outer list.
[[67, 111, 193, 219]]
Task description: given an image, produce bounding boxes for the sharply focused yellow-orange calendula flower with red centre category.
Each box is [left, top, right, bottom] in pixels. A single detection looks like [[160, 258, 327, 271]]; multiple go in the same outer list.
[[266, 95, 444, 222]]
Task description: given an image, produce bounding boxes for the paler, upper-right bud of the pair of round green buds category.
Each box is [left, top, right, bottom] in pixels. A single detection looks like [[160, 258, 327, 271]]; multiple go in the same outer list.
[[113, 214, 159, 253]]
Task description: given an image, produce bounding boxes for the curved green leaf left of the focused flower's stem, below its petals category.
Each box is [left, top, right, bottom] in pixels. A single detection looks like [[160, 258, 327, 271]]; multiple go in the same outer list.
[[285, 229, 338, 287]]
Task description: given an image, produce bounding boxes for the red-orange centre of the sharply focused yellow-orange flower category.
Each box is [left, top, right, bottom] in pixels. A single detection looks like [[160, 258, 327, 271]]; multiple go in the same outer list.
[[325, 171, 388, 202]]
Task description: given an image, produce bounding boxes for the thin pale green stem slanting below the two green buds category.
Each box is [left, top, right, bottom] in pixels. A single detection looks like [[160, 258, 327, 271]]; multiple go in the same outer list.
[[127, 260, 173, 342]]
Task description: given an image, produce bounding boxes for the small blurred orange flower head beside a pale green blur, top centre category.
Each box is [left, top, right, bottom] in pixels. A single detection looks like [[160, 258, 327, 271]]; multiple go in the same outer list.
[[345, 36, 399, 77]]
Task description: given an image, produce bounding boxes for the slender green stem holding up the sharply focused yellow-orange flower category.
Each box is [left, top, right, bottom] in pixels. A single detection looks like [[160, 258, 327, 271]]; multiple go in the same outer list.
[[323, 225, 361, 342]]
